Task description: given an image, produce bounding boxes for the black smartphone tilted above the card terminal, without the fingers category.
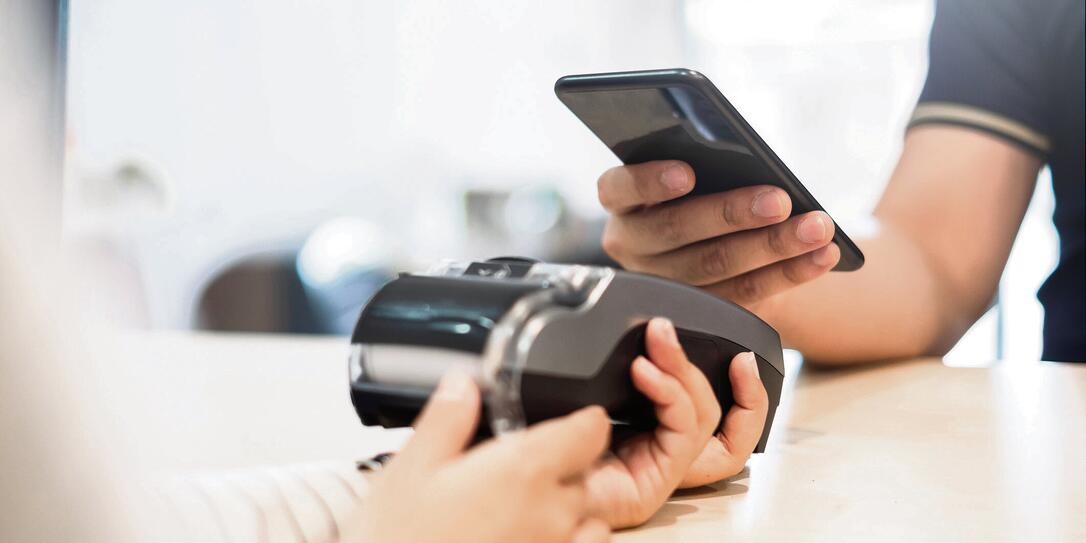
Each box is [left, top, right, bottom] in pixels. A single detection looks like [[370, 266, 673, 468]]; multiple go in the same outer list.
[[554, 68, 863, 272]]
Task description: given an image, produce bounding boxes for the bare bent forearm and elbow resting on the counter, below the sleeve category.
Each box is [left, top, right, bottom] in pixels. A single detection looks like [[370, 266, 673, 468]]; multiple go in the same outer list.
[[753, 125, 1041, 364]]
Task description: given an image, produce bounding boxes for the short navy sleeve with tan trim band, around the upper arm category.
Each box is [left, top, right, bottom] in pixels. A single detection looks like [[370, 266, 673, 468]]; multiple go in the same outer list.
[[909, 0, 1083, 156]]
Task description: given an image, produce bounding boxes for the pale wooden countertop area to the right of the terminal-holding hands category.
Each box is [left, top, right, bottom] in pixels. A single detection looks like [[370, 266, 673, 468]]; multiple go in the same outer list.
[[615, 359, 1086, 543]]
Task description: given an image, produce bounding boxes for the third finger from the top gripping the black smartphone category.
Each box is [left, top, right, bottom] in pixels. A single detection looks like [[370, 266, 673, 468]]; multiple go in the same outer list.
[[633, 211, 834, 286]]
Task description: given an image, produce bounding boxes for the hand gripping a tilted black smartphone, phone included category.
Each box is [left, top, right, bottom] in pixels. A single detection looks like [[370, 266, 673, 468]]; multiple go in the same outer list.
[[555, 70, 863, 307]]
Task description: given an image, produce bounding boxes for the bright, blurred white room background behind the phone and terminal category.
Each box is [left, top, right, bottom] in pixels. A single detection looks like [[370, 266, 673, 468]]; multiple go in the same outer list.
[[64, 0, 1057, 364]]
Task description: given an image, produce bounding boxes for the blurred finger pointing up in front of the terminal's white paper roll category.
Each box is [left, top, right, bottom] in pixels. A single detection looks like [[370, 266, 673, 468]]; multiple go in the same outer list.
[[388, 370, 479, 471]]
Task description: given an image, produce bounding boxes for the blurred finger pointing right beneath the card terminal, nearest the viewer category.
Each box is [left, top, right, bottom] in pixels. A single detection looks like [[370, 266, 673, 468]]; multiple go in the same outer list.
[[515, 405, 610, 479]]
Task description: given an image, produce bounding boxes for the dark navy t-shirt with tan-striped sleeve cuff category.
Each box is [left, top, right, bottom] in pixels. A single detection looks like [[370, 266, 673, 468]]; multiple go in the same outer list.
[[909, 0, 1086, 362]]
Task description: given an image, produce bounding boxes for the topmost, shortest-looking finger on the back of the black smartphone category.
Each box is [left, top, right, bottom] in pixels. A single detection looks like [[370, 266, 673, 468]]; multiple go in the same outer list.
[[596, 161, 694, 214]]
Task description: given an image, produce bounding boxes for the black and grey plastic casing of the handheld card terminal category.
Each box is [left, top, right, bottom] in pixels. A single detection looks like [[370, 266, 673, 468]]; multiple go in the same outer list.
[[351, 262, 784, 452]]
